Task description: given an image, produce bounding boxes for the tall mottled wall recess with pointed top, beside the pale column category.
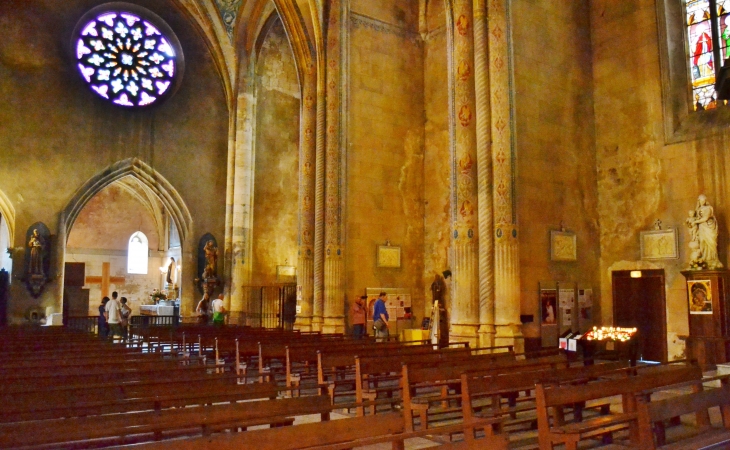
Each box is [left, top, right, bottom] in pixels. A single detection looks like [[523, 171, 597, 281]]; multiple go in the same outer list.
[[251, 19, 300, 285]]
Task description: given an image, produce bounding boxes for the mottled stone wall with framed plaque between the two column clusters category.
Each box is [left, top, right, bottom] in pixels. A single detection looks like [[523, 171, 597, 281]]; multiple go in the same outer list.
[[342, 0, 424, 328]]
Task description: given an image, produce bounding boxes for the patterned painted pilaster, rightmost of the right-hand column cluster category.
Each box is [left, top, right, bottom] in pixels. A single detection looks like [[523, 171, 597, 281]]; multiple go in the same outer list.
[[489, 0, 524, 350]]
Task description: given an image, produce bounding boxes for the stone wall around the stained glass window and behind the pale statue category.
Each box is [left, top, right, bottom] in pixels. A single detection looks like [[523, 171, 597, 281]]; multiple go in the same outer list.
[[591, 0, 730, 359]]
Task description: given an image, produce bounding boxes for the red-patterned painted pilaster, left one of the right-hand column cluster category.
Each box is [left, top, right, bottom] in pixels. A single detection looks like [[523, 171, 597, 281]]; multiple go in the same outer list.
[[449, 0, 479, 344]]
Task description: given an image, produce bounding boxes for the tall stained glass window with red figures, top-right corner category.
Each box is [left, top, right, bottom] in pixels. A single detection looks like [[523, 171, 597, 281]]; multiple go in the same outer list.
[[684, 0, 730, 111]]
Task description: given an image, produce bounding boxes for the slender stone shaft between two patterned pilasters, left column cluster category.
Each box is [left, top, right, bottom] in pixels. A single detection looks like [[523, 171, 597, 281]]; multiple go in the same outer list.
[[312, 61, 326, 331]]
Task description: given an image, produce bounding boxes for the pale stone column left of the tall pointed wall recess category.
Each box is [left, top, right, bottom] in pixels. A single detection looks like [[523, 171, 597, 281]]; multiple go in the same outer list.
[[231, 78, 256, 324]]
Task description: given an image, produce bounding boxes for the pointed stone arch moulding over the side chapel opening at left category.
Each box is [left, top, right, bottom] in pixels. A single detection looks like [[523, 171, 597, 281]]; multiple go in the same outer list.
[[61, 158, 193, 245]]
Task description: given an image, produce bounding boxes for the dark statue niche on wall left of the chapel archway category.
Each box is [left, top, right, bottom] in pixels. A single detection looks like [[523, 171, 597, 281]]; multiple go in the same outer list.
[[25, 222, 51, 298]]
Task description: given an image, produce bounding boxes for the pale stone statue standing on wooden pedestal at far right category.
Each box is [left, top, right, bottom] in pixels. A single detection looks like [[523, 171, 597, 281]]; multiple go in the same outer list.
[[685, 195, 722, 270]]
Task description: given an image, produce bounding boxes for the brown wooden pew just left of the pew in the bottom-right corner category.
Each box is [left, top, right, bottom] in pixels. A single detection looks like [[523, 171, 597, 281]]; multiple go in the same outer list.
[[536, 366, 702, 450]]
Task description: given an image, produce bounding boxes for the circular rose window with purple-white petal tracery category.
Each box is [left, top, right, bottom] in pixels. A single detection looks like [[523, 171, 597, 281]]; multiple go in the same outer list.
[[73, 3, 184, 108]]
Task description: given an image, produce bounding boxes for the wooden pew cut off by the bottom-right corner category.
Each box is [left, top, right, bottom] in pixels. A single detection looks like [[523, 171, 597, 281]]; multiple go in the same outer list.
[[637, 383, 730, 450]]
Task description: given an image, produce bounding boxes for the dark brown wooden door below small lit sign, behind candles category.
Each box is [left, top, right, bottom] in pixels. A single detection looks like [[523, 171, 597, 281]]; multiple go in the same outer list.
[[612, 270, 667, 362]]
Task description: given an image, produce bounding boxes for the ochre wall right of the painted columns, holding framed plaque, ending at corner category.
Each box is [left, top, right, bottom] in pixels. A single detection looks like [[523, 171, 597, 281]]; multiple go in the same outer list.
[[511, 0, 599, 338]]
